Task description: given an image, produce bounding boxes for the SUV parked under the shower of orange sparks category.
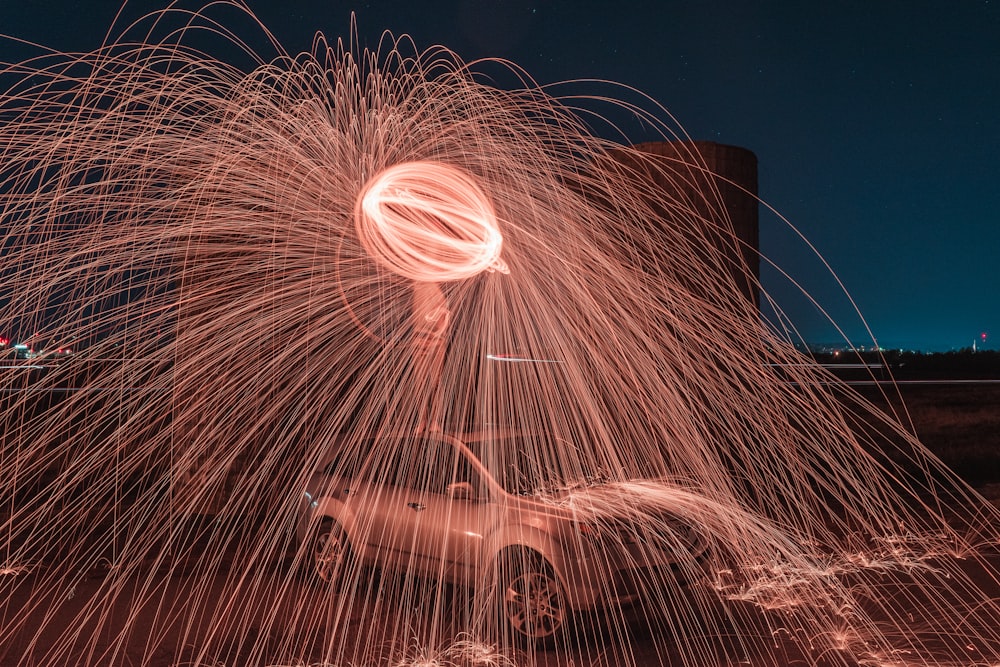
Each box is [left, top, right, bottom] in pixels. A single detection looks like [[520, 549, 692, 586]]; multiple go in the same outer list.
[[296, 433, 710, 642]]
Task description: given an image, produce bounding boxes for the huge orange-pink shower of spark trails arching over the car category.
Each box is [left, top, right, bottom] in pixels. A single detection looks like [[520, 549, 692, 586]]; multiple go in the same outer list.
[[0, 3, 1000, 666]]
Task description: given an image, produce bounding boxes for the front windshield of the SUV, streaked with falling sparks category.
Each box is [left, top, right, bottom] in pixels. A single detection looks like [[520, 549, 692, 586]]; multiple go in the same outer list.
[[466, 435, 609, 495]]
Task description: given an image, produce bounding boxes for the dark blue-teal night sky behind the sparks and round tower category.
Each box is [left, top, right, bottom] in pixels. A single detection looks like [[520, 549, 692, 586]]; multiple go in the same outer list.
[[0, 0, 1000, 350]]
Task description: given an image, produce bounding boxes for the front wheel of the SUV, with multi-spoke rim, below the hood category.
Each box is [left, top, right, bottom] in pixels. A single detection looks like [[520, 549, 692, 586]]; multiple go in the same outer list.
[[500, 558, 566, 644]]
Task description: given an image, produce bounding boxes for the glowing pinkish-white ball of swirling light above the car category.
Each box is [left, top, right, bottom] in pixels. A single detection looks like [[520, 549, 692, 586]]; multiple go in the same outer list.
[[354, 161, 507, 282]]
